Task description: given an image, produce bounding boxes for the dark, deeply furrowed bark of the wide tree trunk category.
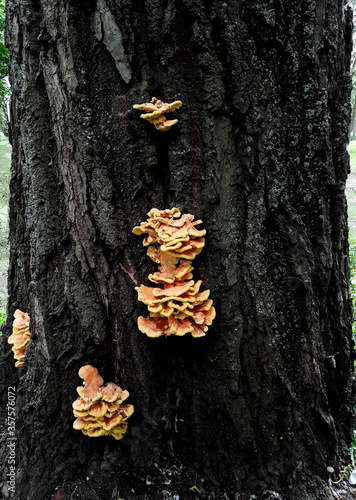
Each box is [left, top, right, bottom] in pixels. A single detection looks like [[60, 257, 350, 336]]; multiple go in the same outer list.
[[1, 0, 353, 500]]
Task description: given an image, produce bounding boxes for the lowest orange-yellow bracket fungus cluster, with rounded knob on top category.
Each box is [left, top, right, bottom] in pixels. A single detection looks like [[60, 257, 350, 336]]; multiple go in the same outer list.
[[73, 365, 134, 439]]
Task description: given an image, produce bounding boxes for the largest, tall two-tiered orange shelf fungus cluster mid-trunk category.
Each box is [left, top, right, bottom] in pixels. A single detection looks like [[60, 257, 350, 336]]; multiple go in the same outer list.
[[133, 208, 215, 337]]
